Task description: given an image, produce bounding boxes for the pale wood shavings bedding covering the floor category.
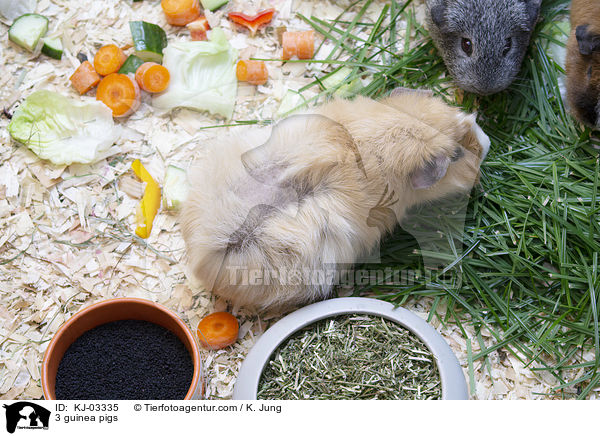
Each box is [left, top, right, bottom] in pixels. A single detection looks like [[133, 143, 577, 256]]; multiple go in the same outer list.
[[0, 0, 594, 399]]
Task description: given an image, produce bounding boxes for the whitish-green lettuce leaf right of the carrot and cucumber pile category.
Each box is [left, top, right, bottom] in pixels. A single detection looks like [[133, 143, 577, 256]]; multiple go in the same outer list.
[[152, 28, 238, 118]]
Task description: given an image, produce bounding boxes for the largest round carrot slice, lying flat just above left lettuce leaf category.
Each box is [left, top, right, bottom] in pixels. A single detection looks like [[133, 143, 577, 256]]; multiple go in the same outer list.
[[96, 73, 140, 117]]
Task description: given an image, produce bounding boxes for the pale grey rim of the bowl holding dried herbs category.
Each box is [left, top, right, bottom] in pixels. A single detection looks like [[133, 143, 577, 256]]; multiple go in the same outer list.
[[233, 298, 469, 400]]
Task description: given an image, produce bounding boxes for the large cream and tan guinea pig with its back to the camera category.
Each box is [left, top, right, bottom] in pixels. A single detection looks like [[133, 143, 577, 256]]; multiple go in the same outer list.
[[180, 92, 489, 312]]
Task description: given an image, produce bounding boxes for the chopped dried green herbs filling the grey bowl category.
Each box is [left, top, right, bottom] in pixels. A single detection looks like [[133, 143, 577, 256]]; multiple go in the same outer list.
[[257, 315, 441, 400]]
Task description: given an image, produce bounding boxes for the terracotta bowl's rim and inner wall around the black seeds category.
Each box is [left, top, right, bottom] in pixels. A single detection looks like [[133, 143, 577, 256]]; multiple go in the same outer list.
[[42, 298, 204, 400]]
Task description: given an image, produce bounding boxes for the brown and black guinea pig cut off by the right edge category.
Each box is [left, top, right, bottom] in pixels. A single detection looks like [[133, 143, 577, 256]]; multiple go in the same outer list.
[[566, 0, 600, 127]]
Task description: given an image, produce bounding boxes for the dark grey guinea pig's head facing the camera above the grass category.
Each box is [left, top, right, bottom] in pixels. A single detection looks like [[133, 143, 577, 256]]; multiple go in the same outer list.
[[426, 0, 542, 95]]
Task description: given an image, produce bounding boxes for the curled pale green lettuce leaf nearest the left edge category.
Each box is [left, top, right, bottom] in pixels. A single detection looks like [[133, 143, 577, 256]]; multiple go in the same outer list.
[[8, 90, 121, 165]]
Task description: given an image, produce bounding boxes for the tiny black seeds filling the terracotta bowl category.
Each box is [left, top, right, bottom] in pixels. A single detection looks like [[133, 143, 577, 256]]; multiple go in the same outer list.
[[55, 320, 194, 400]]
